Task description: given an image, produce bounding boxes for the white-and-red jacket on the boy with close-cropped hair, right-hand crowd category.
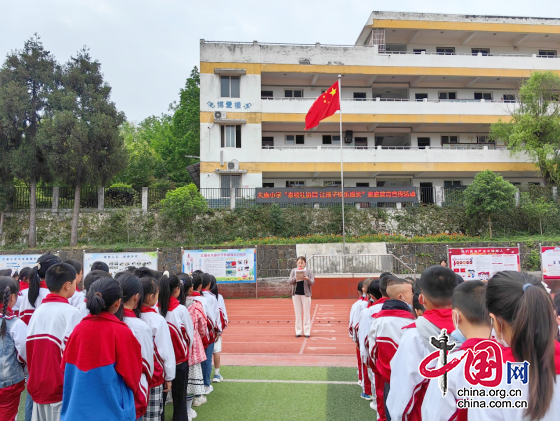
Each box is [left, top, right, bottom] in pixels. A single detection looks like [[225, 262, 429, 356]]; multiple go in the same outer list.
[[368, 300, 414, 383]]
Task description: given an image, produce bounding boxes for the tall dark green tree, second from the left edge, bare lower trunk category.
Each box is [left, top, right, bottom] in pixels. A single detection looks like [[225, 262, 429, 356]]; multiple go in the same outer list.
[[39, 47, 127, 246]]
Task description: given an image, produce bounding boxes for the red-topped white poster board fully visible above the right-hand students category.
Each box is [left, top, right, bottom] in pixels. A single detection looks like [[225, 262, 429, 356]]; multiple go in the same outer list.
[[448, 247, 521, 281]]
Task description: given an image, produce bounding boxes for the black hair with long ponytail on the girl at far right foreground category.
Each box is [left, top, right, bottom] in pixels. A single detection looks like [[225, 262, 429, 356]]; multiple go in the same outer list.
[[486, 271, 558, 421]]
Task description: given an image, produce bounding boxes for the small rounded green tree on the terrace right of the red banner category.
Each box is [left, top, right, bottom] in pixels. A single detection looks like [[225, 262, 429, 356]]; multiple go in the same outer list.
[[463, 170, 516, 238]]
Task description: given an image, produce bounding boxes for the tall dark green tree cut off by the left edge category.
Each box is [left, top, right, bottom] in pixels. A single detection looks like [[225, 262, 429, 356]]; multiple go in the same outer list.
[[0, 34, 59, 247]]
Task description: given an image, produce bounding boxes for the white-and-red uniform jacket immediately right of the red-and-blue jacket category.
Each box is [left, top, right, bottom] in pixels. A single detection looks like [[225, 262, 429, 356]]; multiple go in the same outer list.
[[123, 309, 154, 418]]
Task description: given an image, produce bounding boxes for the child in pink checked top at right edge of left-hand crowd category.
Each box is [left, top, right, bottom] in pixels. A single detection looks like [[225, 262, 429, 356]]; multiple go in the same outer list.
[[183, 275, 208, 419]]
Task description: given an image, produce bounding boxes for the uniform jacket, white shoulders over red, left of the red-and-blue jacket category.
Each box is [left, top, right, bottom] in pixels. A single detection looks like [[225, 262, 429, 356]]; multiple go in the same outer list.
[[26, 294, 82, 404]]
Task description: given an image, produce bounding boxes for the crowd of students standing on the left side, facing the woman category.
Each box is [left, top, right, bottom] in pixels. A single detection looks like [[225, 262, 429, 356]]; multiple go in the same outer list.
[[0, 254, 228, 421]]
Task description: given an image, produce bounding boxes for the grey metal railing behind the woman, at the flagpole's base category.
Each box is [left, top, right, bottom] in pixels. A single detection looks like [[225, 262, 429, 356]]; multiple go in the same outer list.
[[307, 254, 416, 275]]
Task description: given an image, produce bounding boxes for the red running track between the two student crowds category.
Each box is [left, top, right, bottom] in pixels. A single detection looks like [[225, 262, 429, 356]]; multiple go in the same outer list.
[[221, 298, 356, 367]]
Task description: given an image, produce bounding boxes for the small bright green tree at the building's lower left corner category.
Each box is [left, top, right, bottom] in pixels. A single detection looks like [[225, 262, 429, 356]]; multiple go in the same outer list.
[[161, 184, 208, 240]]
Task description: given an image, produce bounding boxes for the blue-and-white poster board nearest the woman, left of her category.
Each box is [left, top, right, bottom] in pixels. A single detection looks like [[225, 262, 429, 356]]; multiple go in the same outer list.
[[183, 249, 257, 283]]
